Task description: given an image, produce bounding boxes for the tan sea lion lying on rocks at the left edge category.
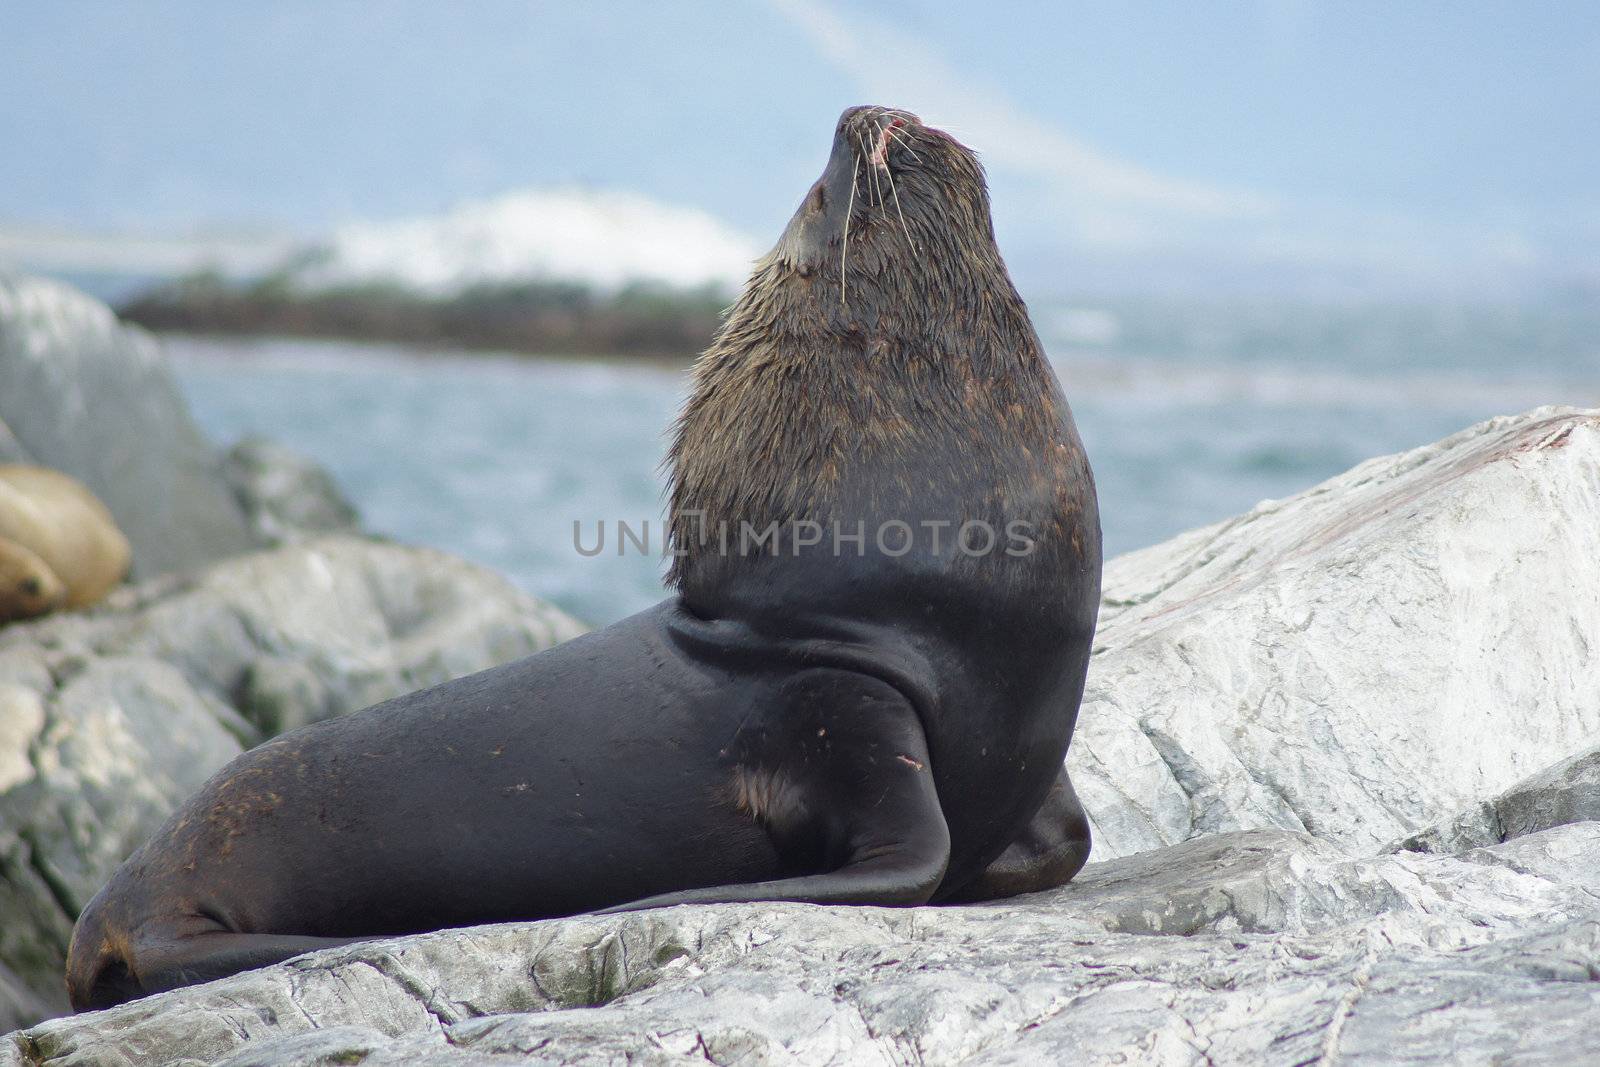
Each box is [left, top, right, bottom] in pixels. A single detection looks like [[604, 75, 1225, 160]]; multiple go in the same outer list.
[[0, 464, 130, 622]]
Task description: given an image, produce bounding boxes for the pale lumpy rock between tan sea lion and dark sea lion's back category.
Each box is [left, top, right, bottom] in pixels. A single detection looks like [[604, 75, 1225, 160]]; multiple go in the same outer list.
[[0, 537, 581, 1009]]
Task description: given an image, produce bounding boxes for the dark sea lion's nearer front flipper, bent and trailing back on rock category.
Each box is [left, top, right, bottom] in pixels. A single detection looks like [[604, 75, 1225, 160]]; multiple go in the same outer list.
[[605, 669, 950, 912]]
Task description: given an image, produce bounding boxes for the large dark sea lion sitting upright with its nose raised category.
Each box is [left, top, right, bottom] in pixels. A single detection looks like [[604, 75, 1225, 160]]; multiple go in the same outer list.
[[67, 107, 1101, 1008]]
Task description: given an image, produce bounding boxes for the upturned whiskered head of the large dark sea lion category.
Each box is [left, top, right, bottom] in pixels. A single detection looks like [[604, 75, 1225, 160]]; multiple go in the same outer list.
[[758, 107, 1010, 320]]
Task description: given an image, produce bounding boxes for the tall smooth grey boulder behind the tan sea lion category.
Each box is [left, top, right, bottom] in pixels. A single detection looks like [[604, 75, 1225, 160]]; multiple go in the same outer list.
[[0, 274, 256, 577]]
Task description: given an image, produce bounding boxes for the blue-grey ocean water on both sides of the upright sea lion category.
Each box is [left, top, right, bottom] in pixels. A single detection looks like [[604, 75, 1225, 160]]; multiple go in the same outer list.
[[166, 302, 1600, 624]]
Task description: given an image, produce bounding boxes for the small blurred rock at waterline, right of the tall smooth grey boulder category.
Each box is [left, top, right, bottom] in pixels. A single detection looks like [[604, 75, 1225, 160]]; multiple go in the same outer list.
[[222, 437, 358, 545]]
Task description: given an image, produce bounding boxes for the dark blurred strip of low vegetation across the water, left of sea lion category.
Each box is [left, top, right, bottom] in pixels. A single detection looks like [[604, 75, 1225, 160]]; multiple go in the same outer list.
[[118, 274, 730, 360]]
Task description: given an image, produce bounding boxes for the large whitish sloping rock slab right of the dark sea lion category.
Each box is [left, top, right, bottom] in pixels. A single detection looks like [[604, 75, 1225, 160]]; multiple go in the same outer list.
[[1067, 408, 1600, 859]]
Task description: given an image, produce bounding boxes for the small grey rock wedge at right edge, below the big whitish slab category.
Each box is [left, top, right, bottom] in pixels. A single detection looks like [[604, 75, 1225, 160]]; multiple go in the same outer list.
[[1394, 749, 1600, 853]]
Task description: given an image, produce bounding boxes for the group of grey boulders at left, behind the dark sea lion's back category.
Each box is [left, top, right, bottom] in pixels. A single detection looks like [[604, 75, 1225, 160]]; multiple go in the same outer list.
[[0, 271, 582, 1030]]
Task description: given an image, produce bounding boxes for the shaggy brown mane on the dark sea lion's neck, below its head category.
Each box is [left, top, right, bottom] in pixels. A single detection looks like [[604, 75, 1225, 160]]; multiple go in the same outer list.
[[669, 262, 1061, 582]]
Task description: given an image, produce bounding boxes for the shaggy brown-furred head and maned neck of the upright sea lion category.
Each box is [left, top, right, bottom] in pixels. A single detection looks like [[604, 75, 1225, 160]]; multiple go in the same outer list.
[[667, 107, 1061, 591]]
